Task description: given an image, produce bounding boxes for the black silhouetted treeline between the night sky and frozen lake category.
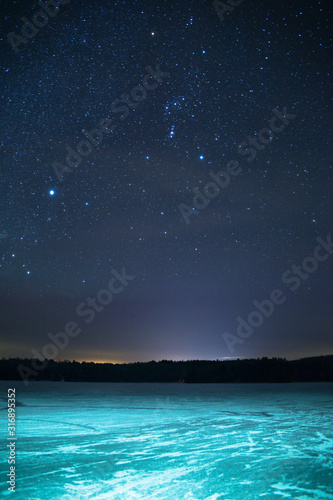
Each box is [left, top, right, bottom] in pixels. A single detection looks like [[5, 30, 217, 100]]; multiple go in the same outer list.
[[0, 355, 333, 384]]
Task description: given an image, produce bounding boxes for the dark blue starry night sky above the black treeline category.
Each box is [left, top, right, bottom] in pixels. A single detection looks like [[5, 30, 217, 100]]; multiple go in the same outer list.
[[0, 0, 333, 362]]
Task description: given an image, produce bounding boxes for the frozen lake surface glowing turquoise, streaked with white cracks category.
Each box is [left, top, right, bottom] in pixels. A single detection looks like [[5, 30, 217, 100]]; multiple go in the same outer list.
[[0, 381, 333, 500]]
